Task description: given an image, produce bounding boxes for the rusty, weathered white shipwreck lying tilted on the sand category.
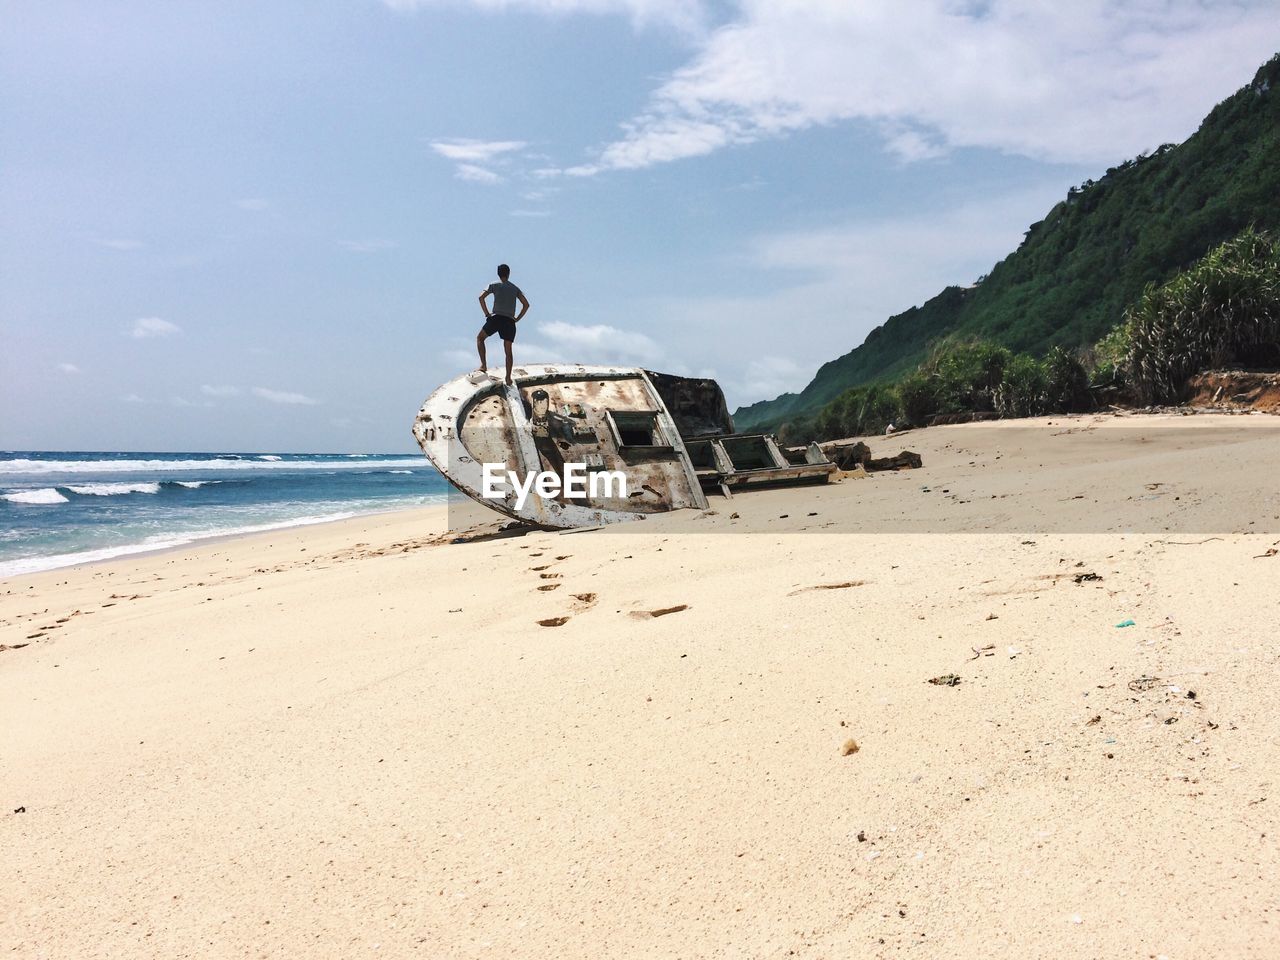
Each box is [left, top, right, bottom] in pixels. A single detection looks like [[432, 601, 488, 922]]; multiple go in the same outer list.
[[413, 364, 837, 529]]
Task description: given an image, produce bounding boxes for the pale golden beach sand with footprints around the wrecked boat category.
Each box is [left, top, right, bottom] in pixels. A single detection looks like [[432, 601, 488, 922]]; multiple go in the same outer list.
[[0, 416, 1280, 960]]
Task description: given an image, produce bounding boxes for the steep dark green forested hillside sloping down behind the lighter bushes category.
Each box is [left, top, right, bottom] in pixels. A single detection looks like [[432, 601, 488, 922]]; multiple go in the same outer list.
[[733, 48, 1280, 430]]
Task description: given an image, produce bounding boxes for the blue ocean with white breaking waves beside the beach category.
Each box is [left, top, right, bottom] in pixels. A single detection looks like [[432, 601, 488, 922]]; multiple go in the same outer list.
[[0, 451, 448, 577]]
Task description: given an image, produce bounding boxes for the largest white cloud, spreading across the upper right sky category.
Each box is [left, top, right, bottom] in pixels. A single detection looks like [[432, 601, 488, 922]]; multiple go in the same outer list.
[[564, 0, 1277, 175]]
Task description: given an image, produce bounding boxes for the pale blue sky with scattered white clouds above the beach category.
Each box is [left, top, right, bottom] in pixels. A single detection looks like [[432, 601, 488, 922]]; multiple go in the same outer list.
[[0, 0, 1280, 452]]
